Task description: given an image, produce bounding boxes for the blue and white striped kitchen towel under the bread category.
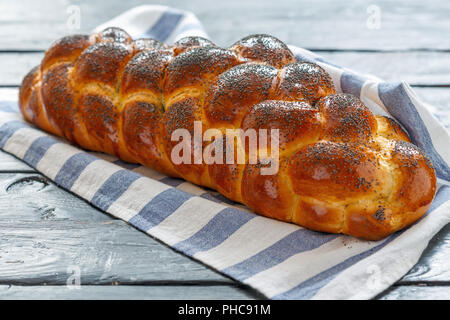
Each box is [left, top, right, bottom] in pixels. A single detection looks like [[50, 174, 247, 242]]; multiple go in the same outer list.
[[0, 6, 450, 299]]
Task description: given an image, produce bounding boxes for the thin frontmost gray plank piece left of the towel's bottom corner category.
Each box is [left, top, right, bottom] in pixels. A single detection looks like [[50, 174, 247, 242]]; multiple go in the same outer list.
[[0, 285, 261, 300]]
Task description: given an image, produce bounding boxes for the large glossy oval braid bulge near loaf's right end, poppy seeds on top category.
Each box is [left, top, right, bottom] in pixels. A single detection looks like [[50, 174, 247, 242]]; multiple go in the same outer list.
[[289, 141, 383, 201]]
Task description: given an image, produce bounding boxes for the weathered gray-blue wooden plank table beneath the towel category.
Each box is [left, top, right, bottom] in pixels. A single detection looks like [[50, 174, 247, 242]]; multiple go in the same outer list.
[[0, 0, 450, 299]]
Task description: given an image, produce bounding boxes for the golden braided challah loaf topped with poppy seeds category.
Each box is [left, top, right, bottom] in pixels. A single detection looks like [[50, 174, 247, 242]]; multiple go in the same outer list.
[[19, 28, 436, 240]]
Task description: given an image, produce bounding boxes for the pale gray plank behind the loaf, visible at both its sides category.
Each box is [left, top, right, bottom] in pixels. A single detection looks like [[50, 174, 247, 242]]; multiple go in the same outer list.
[[0, 51, 450, 86]]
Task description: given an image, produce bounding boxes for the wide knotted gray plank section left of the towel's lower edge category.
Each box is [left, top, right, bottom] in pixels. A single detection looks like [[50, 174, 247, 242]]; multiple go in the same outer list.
[[0, 173, 236, 284]]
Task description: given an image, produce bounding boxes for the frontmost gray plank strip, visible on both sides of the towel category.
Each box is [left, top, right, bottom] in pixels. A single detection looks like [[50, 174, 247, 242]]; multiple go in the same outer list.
[[0, 285, 450, 300]]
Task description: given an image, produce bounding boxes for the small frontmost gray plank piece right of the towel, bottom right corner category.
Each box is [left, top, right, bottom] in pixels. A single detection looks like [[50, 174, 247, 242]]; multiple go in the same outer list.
[[376, 286, 450, 300]]
